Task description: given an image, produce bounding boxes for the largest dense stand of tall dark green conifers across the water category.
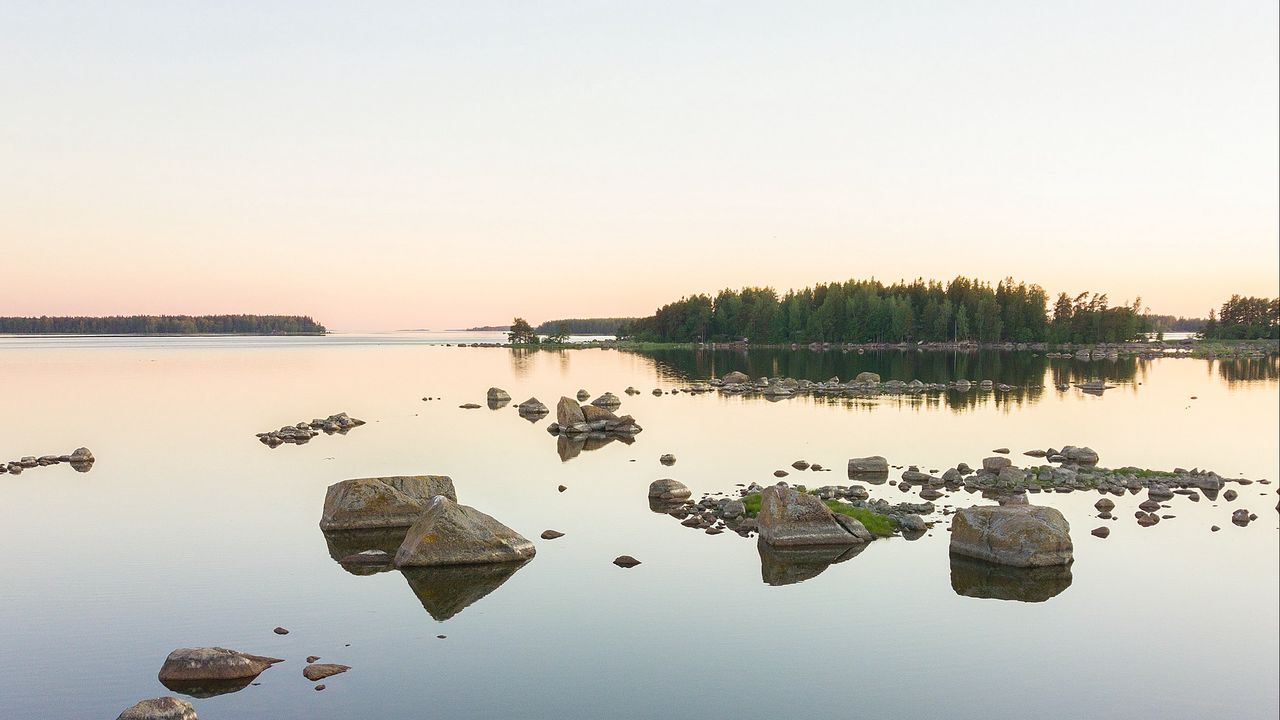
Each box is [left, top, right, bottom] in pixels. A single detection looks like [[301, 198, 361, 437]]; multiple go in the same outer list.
[[620, 277, 1147, 343]]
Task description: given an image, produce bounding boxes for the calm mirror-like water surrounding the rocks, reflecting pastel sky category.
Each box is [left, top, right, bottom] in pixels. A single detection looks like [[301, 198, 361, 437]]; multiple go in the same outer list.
[[0, 333, 1280, 720]]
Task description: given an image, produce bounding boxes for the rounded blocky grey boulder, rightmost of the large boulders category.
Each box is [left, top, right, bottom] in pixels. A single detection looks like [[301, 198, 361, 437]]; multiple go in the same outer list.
[[951, 505, 1073, 568]]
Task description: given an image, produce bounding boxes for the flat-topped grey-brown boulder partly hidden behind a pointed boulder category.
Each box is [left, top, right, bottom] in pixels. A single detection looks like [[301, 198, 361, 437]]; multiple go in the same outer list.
[[320, 475, 458, 530]]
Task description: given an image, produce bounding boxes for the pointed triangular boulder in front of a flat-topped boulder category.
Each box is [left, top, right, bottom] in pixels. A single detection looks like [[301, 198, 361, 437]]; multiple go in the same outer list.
[[396, 496, 534, 568]]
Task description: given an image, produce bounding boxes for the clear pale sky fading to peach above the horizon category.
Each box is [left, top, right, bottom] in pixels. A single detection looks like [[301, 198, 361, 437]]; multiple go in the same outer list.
[[0, 0, 1280, 331]]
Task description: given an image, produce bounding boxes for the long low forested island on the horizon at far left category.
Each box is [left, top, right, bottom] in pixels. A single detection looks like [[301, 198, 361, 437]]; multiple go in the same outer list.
[[0, 315, 328, 336]]
